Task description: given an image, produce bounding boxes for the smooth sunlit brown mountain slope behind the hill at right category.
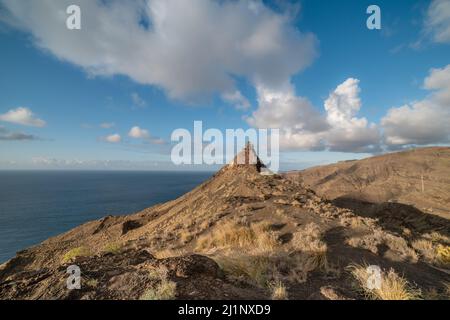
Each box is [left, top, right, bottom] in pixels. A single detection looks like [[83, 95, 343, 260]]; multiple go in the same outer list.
[[288, 147, 450, 219]]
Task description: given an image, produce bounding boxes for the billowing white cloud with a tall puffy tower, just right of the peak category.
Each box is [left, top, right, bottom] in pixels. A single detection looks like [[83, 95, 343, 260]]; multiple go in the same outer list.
[[247, 78, 380, 152]]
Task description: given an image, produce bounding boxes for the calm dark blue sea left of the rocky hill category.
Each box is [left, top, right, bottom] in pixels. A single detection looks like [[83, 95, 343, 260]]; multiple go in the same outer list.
[[0, 171, 213, 263]]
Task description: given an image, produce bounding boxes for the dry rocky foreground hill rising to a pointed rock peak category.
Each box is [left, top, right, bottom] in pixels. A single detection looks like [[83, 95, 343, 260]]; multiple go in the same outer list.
[[0, 146, 450, 299]]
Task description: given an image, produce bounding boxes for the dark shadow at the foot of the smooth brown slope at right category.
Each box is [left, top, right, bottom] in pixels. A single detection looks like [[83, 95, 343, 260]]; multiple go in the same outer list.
[[331, 197, 450, 238]]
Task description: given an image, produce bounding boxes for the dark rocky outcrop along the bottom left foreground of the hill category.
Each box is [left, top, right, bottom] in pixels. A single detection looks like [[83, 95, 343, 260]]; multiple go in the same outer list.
[[0, 250, 264, 300]]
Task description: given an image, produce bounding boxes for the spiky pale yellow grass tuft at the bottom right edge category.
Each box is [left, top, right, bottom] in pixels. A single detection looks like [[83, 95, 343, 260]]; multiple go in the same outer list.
[[348, 265, 422, 300]]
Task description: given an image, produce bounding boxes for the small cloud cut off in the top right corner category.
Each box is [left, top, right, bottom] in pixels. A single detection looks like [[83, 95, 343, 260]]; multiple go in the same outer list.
[[425, 0, 450, 43]]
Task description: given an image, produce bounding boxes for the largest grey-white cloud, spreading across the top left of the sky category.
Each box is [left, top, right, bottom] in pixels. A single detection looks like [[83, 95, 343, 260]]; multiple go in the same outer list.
[[0, 0, 317, 106]]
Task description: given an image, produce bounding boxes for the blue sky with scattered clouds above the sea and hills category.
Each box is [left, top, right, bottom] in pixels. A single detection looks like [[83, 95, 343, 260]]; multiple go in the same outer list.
[[0, 0, 450, 170]]
